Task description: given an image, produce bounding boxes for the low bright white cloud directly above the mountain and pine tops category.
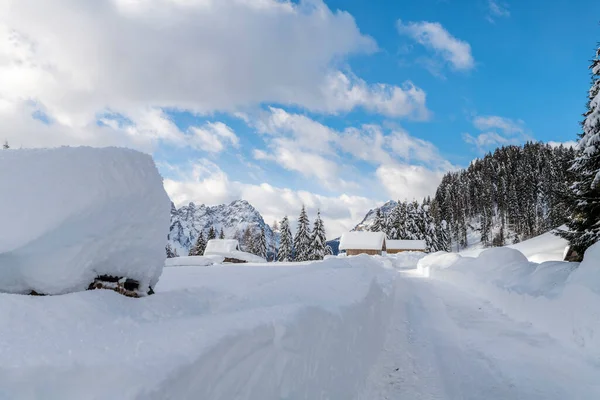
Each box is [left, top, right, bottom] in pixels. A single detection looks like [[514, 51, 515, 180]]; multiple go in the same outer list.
[[163, 160, 380, 239]]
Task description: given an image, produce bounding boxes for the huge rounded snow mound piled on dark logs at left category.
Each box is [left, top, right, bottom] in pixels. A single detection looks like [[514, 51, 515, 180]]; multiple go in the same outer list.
[[0, 147, 170, 294]]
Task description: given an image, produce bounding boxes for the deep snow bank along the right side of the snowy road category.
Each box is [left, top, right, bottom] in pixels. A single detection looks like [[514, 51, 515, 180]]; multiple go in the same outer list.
[[418, 243, 600, 357]]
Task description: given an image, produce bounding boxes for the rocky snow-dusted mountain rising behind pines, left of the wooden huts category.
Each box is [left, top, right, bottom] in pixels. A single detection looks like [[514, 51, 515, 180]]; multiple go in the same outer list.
[[169, 200, 276, 255]]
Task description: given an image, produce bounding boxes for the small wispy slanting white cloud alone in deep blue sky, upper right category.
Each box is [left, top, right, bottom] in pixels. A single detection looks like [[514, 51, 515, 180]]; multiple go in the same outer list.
[[396, 20, 475, 70]]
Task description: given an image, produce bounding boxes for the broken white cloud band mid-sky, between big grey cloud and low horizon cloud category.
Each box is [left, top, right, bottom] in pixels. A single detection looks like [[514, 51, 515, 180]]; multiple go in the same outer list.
[[248, 108, 453, 198]]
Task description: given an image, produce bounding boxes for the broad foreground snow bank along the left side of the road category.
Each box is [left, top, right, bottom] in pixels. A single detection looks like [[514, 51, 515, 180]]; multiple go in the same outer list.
[[0, 256, 394, 400]]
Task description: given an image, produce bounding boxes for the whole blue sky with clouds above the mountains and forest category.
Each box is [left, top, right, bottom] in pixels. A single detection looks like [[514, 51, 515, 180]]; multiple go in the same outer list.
[[0, 0, 600, 235]]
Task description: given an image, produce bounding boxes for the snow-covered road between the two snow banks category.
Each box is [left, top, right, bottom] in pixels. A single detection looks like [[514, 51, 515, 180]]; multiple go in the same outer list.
[[359, 270, 600, 400]]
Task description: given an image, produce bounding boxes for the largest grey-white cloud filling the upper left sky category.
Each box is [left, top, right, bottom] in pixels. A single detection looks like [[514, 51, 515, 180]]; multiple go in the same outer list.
[[0, 0, 428, 148]]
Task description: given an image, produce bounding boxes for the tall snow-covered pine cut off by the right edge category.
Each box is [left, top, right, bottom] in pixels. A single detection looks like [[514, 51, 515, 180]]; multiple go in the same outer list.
[[559, 45, 600, 257]]
